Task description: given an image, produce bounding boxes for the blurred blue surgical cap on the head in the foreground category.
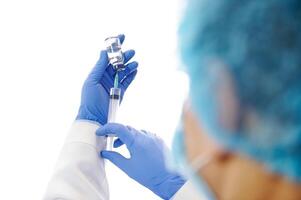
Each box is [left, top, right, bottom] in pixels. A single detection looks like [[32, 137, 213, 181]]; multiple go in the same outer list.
[[179, 0, 301, 182]]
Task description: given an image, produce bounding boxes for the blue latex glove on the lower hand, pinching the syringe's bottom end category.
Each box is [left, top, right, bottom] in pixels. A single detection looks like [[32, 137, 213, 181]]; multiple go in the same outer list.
[[96, 123, 185, 199]]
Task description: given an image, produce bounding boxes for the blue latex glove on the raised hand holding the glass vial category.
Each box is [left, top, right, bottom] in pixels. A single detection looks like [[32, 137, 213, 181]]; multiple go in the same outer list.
[[76, 35, 138, 125]]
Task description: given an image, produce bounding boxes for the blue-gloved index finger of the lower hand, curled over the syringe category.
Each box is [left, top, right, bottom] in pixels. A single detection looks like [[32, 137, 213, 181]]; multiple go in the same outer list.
[[96, 123, 134, 147]]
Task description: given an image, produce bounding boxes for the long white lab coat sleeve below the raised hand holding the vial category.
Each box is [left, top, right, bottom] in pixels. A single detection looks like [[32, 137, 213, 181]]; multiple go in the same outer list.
[[43, 121, 109, 200]]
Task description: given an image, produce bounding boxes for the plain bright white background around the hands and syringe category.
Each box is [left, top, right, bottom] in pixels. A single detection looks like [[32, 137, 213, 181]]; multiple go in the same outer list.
[[0, 0, 188, 200]]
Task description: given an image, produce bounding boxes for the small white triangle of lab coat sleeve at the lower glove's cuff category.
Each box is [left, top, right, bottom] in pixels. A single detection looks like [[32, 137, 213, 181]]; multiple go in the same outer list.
[[171, 180, 206, 200]]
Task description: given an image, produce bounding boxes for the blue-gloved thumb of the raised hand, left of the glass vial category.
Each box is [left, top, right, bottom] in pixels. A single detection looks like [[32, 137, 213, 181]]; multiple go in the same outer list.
[[87, 51, 109, 82]]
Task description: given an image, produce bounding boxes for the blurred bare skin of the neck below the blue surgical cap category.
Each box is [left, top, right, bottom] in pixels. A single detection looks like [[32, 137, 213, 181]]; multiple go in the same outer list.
[[202, 155, 301, 200]]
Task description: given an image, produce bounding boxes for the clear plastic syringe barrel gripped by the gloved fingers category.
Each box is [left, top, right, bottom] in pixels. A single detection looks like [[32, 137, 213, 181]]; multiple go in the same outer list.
[[106, 88, 121, 151]]
